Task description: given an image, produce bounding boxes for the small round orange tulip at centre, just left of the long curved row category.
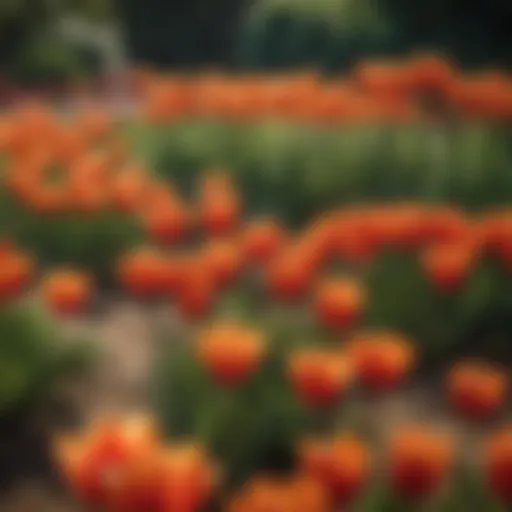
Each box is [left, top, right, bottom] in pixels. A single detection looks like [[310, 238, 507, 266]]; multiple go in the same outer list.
[[241, 219, 285, 264]]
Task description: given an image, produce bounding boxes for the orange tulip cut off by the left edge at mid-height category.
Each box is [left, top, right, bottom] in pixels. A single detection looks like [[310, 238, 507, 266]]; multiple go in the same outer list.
[[0, 245, 34, 303]]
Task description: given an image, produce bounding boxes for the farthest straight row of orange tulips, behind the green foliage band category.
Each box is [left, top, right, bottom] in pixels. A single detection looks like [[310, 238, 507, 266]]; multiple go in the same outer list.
[[135, 55, 512, 125]]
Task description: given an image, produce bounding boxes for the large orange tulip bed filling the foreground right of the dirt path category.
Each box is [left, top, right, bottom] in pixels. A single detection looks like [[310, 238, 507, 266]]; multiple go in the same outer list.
[[51, 173, 511, 512]]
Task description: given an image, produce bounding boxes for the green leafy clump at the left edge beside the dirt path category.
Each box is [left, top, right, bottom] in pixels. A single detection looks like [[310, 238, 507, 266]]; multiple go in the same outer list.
[[0, 302, 88, 417]]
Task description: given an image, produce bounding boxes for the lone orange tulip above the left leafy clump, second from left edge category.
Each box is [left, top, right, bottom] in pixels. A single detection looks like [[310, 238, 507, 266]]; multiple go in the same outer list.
[[41, 269, 92, 314]]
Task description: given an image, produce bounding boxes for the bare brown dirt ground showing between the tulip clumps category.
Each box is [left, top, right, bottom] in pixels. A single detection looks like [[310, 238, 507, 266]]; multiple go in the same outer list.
[[0, 298, 510, 512]]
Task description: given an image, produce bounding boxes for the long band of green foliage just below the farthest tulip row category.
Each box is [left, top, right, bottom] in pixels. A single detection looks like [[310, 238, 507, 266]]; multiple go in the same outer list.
[[127, 120, 512, 224]]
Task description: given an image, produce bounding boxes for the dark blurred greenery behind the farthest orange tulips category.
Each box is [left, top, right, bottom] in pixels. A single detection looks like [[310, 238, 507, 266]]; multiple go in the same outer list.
[[0, 0, 512, 97]]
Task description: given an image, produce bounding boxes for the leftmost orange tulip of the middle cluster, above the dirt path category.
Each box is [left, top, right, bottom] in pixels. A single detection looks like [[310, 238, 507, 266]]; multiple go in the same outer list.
[[117, 247, 167, 298]]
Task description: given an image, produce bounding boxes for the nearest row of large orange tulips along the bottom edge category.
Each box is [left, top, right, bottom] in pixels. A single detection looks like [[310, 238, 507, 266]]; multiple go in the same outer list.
[[55, 416, 512, 512]]
